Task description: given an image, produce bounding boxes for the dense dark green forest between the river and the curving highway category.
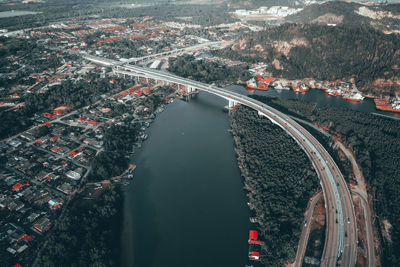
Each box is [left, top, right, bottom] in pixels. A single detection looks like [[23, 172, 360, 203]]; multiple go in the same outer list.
[[231, 106, 319, 266]]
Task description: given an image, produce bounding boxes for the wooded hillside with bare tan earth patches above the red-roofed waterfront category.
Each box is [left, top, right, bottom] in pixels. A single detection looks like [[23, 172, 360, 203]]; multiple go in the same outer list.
[[214, 24, 400, 95]]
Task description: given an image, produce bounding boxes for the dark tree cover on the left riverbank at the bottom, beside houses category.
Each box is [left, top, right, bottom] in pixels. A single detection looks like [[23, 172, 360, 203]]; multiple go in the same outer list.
[[36, 187, 123, 267]]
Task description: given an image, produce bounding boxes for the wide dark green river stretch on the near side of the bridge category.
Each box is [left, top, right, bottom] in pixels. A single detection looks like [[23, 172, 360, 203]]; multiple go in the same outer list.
[[121, 93, 250, 267]]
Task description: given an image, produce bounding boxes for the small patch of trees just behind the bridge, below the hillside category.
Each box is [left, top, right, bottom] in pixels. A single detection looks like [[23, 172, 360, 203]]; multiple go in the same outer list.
[[168, 55, 250, 84]]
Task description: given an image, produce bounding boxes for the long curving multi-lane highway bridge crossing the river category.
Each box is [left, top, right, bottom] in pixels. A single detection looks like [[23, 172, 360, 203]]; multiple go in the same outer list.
[[86, 56, 357, 267]]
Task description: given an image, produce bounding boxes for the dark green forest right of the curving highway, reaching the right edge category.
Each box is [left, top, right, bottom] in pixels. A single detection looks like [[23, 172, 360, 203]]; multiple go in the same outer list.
[[250, 98, 400, 266]]
